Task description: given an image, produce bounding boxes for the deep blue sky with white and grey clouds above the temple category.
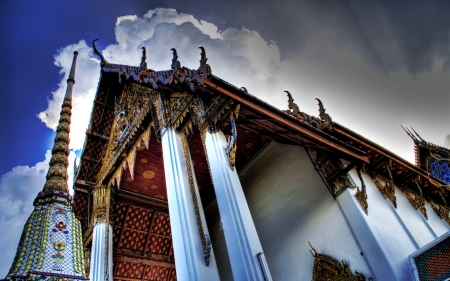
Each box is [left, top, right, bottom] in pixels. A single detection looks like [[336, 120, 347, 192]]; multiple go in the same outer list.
[[0, 0, 450, 277]]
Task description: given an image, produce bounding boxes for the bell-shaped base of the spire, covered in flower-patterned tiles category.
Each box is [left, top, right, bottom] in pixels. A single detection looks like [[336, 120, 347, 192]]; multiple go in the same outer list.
[[8, 203, 85, 277]]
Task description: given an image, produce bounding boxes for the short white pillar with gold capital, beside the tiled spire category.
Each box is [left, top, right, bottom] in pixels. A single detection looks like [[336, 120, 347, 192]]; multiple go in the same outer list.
[[89, 185, 113, 281]]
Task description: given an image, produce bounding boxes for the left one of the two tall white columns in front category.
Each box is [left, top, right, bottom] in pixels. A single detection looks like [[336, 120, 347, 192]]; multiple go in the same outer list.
[[161, 129, 220, 281]]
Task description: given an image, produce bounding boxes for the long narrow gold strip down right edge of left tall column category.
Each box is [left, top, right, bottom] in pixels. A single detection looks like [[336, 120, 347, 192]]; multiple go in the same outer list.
[[181, 131, 211, 265]]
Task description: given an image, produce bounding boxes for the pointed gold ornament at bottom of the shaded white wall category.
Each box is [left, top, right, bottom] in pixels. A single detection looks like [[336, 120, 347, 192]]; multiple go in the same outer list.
[[308, 242, 366, 281]]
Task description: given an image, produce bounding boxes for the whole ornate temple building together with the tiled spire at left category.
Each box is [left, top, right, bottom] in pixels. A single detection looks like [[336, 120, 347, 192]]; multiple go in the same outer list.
[[7, 40, 450, 281]]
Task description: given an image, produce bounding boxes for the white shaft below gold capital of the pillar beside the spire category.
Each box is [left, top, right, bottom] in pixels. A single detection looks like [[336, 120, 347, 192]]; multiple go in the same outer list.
[[89, 221, 113, 281]]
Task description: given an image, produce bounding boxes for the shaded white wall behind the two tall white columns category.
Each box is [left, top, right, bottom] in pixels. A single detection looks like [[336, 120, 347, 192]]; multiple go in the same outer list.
[[205, 142, 372, 280]]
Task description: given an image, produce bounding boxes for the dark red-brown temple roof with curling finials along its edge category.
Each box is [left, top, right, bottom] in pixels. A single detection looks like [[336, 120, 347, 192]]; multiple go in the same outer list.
[[75, 40, 450, 211]]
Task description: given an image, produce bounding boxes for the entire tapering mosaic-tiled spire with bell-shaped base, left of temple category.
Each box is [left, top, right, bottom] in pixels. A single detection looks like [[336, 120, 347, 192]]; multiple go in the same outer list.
[[6, 52, 87, 281]]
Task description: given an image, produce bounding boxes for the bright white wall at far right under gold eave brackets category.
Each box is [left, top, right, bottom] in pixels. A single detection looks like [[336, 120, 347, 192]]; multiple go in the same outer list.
[[349, 164, 448, 281]]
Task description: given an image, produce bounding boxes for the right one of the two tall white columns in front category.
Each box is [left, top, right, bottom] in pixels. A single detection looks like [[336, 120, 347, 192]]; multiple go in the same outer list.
[[205, 131, 271, 281]]
